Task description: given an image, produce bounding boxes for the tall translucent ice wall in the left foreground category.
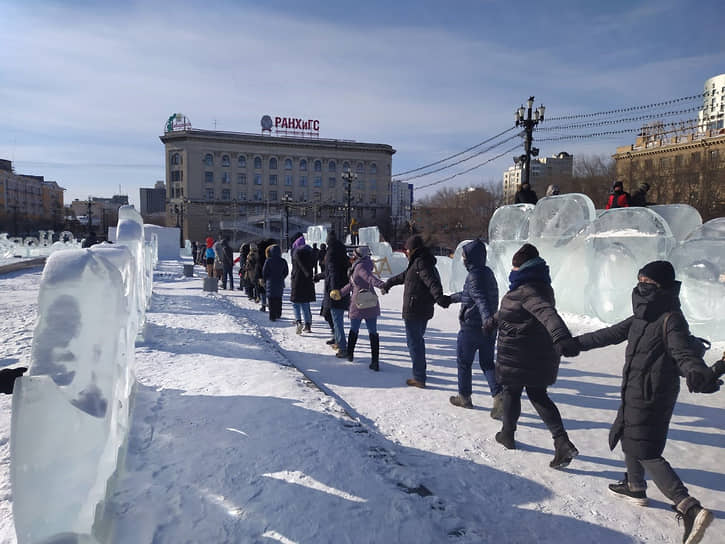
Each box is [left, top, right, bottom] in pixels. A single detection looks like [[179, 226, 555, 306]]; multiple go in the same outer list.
[[10, 205, 151, 544]]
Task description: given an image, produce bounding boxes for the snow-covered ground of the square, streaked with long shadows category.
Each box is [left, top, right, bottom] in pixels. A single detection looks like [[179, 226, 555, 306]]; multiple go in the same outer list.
[[0, 262, 725, 544]]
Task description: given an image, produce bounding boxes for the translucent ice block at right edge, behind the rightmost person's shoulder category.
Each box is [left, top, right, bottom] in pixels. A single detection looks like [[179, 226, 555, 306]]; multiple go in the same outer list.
[[669, 217, 725, 340]]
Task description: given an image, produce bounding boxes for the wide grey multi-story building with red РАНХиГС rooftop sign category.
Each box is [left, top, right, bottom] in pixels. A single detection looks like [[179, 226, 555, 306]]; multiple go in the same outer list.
[[160, 118, 395, 246]]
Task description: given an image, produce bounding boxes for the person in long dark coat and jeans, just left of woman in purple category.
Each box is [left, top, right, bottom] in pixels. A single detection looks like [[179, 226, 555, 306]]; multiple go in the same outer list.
[[322, 231, 350, 359]]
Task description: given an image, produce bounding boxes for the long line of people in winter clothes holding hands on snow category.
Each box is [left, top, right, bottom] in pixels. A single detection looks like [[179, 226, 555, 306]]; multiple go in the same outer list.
[[191, 230, 725, 543]]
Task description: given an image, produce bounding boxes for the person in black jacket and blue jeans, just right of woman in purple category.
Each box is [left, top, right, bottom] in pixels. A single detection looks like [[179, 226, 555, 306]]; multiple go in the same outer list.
[[381, 234, 451, 388]]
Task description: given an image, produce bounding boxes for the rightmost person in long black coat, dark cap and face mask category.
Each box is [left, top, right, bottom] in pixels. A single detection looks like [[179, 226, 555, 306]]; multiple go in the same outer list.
[[575, 261, 725, 544]]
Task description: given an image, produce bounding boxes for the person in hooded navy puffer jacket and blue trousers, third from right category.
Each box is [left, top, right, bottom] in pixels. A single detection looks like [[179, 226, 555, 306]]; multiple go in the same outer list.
[[450, 239, 503, 419]]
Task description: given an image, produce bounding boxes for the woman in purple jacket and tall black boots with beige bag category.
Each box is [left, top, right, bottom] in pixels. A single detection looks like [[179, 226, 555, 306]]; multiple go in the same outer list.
[[330, 246, 385, 371]]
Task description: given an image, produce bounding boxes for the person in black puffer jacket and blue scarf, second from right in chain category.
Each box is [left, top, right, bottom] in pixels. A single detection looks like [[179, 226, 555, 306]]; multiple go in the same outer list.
[[495, 244, 579, 468]]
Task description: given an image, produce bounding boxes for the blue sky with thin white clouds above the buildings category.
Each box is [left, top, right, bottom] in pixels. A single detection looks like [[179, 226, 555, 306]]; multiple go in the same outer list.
[[0, 0, 725, 206]]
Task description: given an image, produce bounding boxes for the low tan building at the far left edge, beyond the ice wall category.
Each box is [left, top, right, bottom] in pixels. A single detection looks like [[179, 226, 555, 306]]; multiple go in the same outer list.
[[0, 159, 65, 232]]
